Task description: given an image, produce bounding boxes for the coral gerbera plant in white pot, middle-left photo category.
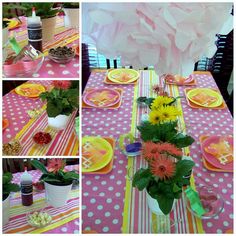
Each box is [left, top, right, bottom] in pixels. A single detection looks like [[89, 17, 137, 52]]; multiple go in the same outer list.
[[40, 80, 79, 129]]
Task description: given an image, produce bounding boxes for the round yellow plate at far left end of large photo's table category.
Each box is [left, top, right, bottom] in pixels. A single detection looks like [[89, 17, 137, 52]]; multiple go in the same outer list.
[[107, 69, 139, 84]]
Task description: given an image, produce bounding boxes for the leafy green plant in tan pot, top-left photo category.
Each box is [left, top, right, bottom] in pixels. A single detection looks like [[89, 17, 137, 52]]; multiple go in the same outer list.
[[20, 2, 62, 42]]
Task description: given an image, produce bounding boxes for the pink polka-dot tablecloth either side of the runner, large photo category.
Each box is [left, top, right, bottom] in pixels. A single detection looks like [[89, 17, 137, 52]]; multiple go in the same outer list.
[[82, 71, 233, 234]]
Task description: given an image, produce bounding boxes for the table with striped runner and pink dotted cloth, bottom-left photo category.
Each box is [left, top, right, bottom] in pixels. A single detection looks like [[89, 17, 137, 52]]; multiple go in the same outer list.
[[3, 165, 80, 234]]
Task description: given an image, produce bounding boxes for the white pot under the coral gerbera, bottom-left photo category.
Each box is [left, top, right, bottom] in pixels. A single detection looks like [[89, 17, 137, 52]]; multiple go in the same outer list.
[[44, 182, 72, 207]]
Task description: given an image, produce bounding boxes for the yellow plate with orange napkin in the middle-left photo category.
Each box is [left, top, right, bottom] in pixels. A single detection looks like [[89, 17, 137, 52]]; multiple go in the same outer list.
[[15, 84, 46, 98]]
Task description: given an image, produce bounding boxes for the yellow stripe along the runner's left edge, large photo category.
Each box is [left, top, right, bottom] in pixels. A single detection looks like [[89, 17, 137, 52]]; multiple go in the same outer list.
[[122, 70, 139, 233]]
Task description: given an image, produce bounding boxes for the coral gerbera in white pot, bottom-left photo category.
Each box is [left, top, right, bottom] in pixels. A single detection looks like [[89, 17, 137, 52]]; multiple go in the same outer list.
[[31, 158, 79, 207]]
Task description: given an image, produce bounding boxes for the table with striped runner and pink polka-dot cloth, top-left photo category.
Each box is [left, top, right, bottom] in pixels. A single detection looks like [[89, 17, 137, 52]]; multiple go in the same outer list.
[[4, 15, 80, 78]]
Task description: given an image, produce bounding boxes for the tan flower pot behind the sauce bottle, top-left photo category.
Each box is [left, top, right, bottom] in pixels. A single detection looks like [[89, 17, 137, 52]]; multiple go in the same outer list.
[[42, 16, 57, 42]]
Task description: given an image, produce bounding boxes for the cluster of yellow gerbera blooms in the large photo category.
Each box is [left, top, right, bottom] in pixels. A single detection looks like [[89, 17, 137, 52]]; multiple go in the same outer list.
[[149, 106, 181, 124]]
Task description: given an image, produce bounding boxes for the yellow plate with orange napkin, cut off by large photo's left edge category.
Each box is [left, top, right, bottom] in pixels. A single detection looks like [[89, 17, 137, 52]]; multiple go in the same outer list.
[[82, 136, 113, 173]]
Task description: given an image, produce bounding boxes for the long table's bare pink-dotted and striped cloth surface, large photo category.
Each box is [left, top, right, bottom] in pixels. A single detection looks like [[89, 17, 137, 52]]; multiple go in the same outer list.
[[82, 69, 234, 234]]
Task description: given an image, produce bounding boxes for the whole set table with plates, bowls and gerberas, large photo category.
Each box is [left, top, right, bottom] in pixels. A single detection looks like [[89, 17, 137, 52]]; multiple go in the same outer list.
[[82, 69, 233, 233]]
